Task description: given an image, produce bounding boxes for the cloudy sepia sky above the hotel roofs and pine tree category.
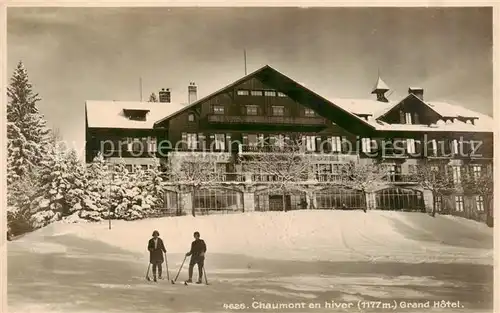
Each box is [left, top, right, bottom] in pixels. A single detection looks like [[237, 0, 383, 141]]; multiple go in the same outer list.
[[7, 7, 493, 152]]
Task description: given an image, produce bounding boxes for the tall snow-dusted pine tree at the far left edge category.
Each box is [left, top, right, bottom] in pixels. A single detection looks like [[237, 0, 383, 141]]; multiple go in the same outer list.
[[7, 62, 49, 183]]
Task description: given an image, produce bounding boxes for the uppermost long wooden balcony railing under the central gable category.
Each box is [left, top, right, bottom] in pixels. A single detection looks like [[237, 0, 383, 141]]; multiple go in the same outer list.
[[207, 114, 328, 126]]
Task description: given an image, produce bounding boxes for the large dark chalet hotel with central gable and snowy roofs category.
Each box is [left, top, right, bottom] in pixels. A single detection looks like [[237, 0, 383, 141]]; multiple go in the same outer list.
[[86, 66, 493, 220]]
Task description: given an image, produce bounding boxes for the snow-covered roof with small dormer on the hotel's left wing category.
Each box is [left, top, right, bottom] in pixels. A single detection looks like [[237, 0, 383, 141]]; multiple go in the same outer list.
[[85, 100, 184, 129]]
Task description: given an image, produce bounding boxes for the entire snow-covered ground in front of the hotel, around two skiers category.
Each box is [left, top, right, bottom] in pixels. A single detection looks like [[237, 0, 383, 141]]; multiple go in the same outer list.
[[8, 211, 493, 313]]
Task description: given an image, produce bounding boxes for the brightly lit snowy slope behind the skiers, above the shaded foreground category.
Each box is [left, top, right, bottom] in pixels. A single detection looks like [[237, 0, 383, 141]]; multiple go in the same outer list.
[[19, 211, 493, 265]]
